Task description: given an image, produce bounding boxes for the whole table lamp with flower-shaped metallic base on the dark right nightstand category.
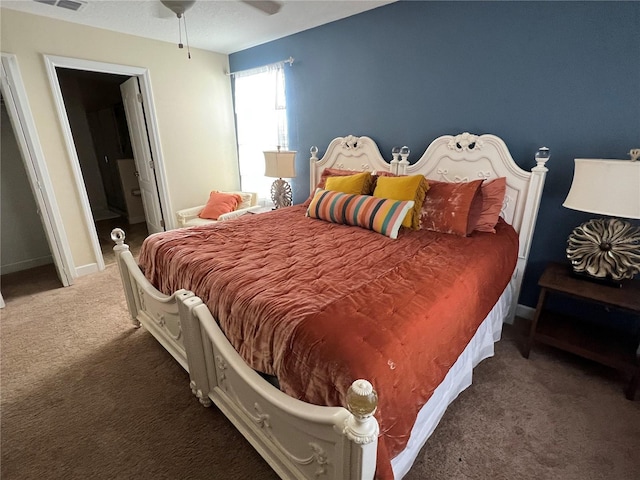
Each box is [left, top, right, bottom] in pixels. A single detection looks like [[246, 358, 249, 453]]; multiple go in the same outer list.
[[562, 155, 640, 286]]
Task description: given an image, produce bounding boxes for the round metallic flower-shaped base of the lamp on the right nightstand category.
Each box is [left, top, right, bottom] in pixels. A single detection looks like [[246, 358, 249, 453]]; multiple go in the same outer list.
[[566, 218, 640, 282]]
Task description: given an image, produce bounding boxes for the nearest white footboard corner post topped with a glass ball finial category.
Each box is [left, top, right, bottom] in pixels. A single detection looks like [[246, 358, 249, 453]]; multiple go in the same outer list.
[[343, 380, 379, 480]]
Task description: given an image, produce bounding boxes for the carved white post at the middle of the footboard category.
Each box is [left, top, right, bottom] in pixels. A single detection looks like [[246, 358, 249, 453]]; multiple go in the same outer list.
[[176, 290, 211, 407]]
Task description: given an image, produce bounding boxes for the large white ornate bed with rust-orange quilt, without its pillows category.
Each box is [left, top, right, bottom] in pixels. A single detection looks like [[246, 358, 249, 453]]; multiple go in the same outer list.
[[112, 133, 547, 480]]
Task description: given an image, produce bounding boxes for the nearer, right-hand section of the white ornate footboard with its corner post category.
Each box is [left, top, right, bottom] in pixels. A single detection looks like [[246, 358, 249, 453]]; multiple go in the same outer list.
[[177, 296, 378, 480]]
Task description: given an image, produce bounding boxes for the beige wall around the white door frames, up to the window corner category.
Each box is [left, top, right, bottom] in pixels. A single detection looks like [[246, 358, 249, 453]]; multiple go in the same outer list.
[[0, 8, 239, 267]]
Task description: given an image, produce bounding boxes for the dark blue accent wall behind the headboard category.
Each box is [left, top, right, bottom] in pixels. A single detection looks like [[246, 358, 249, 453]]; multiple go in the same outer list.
[[229, 1, 640, 306]]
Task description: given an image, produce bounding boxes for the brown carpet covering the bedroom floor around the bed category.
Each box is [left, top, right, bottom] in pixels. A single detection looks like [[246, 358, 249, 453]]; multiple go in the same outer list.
[[0, 265, 640, 480]]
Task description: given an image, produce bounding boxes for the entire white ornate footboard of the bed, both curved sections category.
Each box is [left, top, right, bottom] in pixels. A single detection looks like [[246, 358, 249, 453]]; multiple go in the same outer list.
[[111, 229, 378, 480]]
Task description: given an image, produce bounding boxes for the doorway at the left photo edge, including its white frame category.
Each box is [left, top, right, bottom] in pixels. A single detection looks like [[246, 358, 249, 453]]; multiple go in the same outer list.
[[0, 53, 75, 307]]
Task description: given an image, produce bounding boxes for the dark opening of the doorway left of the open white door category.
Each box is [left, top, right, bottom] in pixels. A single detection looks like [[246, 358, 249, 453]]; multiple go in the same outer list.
[[56, 68, 150, 265]]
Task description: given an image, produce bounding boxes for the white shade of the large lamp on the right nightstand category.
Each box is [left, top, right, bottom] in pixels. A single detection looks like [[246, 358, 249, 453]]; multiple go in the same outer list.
[[562, 158, 640, 218]]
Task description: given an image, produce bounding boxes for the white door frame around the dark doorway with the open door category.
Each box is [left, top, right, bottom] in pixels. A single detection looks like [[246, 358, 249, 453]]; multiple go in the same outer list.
[[43, 55, 175, 276]]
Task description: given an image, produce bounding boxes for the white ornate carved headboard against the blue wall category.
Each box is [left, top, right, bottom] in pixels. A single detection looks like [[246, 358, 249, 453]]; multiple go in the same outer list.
[[310, 132, 548, 313]]
